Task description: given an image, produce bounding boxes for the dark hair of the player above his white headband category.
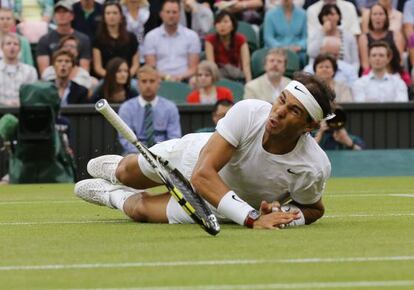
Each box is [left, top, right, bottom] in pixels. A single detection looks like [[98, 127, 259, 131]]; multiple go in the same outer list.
[[293, 72, 335, 118]]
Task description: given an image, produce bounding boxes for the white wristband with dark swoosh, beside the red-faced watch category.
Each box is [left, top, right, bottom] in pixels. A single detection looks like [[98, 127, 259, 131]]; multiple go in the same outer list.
[[217, 190, 254, 226]]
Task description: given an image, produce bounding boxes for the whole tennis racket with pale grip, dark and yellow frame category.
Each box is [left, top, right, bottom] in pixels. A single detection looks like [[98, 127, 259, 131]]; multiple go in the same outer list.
[[95, 99, 220, 235]]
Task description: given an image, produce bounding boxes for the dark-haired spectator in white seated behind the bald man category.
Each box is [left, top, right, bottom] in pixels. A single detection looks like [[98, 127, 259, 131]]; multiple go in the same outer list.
[[308, 4, 359, 70]]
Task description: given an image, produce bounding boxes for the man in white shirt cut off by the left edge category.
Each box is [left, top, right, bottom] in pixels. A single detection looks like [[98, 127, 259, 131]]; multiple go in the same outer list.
[[0, 32, 37, 106]]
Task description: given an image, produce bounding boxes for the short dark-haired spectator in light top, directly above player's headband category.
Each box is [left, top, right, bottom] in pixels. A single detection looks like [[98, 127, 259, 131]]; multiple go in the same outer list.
[[313, 54, 353, 103]]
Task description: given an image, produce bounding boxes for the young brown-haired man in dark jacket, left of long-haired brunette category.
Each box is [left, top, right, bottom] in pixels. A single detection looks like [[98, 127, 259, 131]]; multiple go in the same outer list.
[[52, 49, 90, 106]]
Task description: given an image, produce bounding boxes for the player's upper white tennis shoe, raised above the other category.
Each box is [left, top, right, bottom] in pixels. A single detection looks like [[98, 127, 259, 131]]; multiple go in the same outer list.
[[86, 155, 123, 184]]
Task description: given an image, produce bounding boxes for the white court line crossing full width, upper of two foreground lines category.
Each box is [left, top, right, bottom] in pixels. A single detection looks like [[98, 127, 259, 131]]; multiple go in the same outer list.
[[0, 256, 414, 272]]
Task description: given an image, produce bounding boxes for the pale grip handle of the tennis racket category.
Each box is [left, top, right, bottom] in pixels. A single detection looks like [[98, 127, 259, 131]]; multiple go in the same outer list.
[[95, 99, 138, 144]]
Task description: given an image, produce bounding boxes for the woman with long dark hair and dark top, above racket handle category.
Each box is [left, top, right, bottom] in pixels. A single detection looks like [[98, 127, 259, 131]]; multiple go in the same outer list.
[[92, 57, 138, 103]]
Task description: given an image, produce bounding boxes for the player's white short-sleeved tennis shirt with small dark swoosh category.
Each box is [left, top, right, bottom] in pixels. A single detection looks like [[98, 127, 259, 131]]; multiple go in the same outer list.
[[217, 100, 331, 208]]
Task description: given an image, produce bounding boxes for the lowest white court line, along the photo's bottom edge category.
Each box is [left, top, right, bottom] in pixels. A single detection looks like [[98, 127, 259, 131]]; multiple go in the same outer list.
[[63, 280, 414, 290]]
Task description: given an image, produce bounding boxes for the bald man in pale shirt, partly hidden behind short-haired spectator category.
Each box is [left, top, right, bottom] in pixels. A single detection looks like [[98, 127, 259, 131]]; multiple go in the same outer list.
[[303, 36, 358, 87]]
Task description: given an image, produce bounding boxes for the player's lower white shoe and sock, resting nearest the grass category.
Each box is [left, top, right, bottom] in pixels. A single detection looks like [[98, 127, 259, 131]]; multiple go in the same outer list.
[[74, 178, 138, 208]]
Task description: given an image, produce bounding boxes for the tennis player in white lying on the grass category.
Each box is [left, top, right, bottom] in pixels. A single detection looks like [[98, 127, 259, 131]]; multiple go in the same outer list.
[[75, 74, 334, 229]]
